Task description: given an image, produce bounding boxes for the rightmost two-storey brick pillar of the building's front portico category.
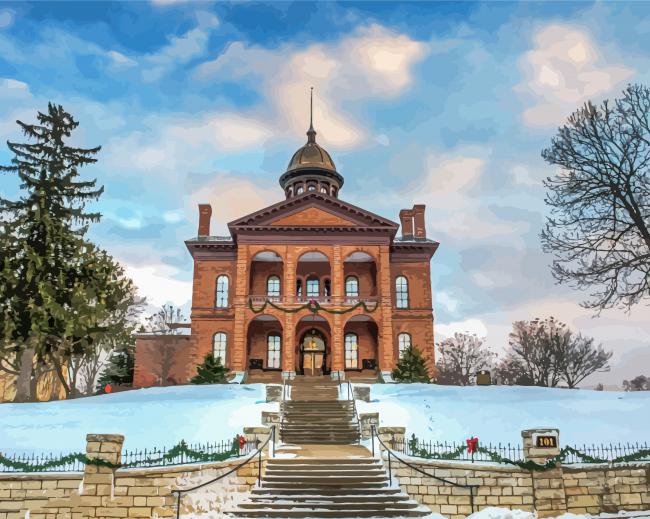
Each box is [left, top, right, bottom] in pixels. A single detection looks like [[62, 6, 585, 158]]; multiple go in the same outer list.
[[375, 245, 395, 378]]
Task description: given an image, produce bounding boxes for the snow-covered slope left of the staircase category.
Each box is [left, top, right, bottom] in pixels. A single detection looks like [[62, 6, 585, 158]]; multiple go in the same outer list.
[[0, 384, 278, 454]]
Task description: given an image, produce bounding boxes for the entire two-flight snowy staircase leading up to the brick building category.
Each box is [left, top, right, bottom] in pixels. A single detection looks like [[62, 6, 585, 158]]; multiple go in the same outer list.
[[227, 379, 431, 519]]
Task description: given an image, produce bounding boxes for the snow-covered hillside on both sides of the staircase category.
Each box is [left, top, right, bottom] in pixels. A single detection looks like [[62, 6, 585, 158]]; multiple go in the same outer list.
[[0, 384, 650, 453]]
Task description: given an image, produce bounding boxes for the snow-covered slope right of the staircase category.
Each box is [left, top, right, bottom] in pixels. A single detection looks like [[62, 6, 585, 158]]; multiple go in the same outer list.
[[357, 384, 650, 445]]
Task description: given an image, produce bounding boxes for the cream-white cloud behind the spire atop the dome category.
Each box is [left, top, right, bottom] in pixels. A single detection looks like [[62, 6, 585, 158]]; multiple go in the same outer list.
[[195, 25, 428, 149]]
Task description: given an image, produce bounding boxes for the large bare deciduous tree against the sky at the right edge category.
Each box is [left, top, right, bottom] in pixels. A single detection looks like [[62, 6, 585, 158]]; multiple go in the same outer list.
[[541, 85, 650, 311]]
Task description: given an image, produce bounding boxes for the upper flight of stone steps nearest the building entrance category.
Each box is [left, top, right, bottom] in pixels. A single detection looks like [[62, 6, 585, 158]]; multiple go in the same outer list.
[[280, 378, 359, 445]]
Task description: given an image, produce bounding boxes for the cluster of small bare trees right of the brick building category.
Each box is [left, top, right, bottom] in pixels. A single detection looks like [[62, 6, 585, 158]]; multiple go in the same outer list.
[[436, 317, 612, 388]]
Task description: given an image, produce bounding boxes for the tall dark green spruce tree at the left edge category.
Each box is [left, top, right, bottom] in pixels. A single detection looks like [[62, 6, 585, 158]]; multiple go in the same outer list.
[[0, 103, 135, 401]]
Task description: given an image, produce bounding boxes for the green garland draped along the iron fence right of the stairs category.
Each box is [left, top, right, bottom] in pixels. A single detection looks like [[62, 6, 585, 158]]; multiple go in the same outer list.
[[409, 435, 650, 471]]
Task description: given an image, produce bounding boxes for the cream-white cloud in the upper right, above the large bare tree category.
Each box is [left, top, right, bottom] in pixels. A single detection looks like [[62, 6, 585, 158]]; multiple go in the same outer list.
[[516, 24, 635, 126]]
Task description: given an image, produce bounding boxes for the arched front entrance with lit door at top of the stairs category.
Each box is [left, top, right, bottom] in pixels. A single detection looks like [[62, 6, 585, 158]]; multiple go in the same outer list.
[[295, 316, 332, 377]]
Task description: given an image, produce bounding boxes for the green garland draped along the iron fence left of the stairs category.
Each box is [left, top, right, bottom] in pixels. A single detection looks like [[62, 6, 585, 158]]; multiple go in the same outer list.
[[0, 436, 240, 472]]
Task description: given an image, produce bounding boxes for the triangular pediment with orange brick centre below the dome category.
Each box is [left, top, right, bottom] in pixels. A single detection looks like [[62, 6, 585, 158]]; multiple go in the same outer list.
[[228, 193, 398, 230]]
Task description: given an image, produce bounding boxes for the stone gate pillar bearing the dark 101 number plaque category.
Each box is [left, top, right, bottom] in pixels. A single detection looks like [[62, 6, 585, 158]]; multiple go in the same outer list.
[[521, 428, 567, 517]]
